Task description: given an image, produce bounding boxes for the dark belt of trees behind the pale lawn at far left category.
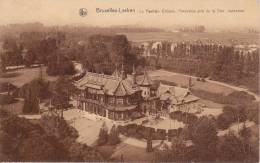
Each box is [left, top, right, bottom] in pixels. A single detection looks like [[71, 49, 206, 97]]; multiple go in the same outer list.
[[1, 32, 74, 75]]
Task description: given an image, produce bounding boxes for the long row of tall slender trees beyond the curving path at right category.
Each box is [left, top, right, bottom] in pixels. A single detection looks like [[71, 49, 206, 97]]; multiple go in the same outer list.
[[147, 42, 259, 92]]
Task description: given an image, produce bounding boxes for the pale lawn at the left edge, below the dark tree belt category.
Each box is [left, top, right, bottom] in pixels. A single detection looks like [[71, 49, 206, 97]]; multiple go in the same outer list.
[[0, 67, 57, 87]]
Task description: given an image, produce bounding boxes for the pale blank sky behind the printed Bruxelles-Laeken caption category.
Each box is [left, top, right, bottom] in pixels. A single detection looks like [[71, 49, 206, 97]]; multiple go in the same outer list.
[[0, 0, 260, 27]]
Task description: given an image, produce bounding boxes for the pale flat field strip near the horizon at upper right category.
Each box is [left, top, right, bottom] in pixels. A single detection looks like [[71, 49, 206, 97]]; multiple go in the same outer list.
[[120, 32, 258, 44]]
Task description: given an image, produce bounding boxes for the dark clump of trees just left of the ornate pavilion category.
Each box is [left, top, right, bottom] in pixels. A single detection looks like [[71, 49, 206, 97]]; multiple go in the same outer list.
[[13, 76, 74, 114]]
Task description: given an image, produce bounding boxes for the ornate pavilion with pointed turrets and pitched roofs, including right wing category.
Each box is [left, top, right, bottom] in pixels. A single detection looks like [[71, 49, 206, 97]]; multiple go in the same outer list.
[[75, 67, 198, 121]]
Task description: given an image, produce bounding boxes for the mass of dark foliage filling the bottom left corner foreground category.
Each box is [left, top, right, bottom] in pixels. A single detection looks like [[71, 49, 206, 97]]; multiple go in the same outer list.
[[0, 114, 103, 161]]
